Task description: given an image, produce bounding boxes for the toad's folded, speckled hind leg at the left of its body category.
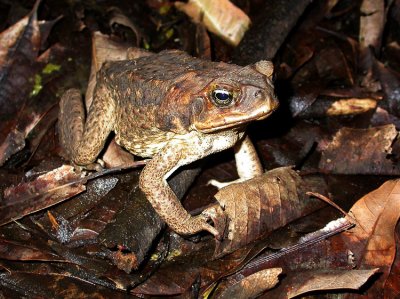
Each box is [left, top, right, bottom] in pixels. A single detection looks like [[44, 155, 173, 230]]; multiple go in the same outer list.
[[59, 86, 115, 165]]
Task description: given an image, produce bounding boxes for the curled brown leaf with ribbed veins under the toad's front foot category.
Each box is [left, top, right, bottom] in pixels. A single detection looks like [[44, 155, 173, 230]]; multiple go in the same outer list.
[[215, 167, 323, 256]]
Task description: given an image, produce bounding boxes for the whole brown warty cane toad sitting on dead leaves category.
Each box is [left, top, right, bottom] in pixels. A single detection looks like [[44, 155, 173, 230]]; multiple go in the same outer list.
[[59, 50, 278, 237]]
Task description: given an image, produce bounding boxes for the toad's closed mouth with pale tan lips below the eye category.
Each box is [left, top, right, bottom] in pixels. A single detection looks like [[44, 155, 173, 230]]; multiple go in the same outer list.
[[192, 101, 278, 133]]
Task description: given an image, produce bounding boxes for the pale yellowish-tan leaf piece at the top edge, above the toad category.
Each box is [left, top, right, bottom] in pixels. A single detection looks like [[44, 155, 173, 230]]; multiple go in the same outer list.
[[175, 0, 250, 46]]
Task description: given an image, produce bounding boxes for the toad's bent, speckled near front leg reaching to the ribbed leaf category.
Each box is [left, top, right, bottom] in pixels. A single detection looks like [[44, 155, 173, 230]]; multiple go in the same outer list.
[[139, 145, 220, 238]]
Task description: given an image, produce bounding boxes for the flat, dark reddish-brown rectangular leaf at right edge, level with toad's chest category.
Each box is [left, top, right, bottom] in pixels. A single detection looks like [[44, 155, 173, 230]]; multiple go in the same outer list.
[[319, 125, 400, 175]]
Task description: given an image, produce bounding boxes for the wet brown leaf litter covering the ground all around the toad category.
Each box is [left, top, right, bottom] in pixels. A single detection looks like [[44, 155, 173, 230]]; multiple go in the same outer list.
[[0, 0, 400, 298]]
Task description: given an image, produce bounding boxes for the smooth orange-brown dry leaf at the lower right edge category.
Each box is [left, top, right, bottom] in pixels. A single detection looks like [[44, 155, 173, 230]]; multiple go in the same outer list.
[[338, 180, 400, 298]]
